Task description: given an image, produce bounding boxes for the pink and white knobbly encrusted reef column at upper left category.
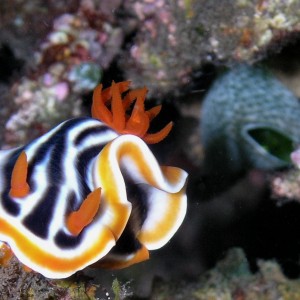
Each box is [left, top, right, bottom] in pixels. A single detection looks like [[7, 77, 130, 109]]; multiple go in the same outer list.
[[1, 1, 123, 147]]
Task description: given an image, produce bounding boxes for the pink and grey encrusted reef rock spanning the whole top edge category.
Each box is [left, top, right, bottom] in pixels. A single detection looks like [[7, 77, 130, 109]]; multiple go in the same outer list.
[[0, 0, 299, 146]]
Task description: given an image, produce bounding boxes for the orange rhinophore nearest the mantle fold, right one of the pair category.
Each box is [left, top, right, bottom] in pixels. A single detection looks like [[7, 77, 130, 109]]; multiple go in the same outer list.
[[67, 188, 101, 235]]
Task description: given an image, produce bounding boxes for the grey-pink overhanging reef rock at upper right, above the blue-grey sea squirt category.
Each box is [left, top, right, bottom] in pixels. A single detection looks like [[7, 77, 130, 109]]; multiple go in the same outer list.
[[122, 0, 300, 95]]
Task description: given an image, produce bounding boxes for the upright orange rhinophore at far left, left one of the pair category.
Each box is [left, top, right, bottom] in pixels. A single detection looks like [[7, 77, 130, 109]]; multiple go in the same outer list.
[[9, 151, 30, 198]]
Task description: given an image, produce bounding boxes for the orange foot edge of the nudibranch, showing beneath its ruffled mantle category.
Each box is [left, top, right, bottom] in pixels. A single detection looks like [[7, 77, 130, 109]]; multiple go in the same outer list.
[[93, 245, 149, 269]]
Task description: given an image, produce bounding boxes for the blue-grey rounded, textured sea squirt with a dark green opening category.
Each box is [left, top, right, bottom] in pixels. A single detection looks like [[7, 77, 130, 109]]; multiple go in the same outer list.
[[200, 65, 300, 173]]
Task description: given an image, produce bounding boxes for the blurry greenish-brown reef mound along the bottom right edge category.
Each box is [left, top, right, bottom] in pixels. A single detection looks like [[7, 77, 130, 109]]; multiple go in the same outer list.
[[150, 248, 300, 300]]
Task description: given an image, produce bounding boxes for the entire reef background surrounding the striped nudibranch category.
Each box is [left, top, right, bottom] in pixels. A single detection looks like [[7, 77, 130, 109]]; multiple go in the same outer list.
[[0, 0, 300, 300]]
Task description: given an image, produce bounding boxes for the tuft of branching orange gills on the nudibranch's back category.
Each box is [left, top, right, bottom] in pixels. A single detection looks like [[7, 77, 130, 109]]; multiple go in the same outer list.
[[92, 81, 173, 144]]
